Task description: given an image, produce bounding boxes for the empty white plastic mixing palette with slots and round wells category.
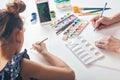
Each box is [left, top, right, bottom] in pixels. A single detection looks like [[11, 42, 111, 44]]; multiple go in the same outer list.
[[66, 36, 104, 64]]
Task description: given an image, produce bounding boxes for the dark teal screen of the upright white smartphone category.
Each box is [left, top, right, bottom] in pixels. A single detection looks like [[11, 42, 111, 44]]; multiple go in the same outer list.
[[37, 2, 51, 22]]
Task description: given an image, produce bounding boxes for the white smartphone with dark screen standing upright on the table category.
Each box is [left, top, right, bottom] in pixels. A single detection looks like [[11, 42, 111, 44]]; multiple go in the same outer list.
[[36, 0, 51, 24]]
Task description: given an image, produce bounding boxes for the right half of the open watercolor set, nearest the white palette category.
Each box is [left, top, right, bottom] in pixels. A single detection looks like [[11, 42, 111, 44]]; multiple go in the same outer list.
[[62, 18, 88, 41]]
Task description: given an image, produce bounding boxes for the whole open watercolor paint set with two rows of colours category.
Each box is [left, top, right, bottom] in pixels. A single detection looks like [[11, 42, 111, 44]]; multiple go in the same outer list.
[[51, 13, 88, 41]]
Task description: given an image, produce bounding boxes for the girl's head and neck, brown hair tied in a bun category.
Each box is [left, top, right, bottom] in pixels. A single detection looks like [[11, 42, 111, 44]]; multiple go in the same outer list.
[[0, 0, 26, 51]]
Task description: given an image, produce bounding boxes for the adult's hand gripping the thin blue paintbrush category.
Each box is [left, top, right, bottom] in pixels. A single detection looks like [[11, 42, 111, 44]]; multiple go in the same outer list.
[[91, 16, 112, 30]]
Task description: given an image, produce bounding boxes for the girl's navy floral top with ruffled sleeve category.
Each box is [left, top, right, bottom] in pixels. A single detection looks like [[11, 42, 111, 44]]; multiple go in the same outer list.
[[4, 50, 29, 80]]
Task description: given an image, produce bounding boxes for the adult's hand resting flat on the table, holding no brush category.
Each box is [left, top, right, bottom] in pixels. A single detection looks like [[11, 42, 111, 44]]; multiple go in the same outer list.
[[95, 36, 120, 53]]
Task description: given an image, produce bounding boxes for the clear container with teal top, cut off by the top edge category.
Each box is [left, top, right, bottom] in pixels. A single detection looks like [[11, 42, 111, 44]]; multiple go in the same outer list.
[[54, 0, 72, 10]]
